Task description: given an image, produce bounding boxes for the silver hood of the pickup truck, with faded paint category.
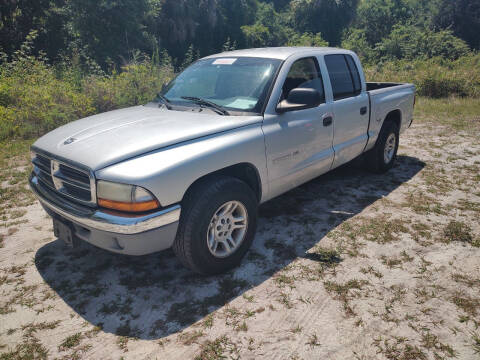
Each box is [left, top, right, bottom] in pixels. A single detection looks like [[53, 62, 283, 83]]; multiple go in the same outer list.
[[32, 105, 262, 171]]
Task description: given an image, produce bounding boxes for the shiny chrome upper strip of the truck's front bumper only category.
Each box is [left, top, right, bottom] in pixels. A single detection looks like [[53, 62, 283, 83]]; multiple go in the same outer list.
[[29, 174, 181, 235]]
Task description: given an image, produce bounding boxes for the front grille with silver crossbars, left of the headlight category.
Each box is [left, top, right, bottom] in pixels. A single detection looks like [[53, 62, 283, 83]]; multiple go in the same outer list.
[[32, 154, 96, 206]]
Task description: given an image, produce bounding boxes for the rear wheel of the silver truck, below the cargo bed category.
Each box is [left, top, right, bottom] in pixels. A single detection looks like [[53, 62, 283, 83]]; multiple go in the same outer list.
[[365, 120, 399, 174]]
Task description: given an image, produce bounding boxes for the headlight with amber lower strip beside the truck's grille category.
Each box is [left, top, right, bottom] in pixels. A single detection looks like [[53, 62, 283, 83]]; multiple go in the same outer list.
[[97, 180, 160, 212]]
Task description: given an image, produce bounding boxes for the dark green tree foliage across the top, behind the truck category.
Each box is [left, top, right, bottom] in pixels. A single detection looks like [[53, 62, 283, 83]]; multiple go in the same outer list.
[[0, 0, 480, 71]]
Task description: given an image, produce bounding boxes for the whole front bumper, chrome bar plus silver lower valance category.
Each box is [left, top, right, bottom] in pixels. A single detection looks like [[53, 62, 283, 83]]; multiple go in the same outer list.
[[29, 173, 181, 255]]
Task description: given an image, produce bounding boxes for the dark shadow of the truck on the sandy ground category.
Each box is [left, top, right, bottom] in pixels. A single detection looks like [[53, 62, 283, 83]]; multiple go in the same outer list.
[[35, 156, 425, 339]]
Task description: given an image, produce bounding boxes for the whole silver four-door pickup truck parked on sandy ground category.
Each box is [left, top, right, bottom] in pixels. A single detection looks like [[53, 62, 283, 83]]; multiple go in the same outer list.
[[30, 47, 415, 274]]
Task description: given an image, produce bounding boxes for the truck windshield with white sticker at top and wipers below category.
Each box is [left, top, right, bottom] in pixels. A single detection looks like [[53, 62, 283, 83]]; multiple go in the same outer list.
[[162, 57, 281, 113]]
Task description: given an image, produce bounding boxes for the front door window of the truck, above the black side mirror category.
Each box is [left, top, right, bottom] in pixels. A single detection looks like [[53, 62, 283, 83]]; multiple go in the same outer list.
[[282, 57, 325, 99]]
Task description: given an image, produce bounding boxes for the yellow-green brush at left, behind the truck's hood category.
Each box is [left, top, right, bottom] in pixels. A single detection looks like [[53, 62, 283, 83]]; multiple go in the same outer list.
[[0, 56, 173, 140]]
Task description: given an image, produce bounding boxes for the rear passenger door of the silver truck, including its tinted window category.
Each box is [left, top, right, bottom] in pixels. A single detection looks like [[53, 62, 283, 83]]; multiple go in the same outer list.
[[324, 54, 369, 168]]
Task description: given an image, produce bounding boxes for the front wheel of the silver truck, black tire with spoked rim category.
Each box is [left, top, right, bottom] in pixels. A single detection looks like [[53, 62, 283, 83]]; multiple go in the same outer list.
[[173, 176, 258, 275]]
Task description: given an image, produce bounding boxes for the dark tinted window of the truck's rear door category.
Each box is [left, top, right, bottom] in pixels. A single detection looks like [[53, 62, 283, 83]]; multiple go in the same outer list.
[[325, 54, 360, 100]]
